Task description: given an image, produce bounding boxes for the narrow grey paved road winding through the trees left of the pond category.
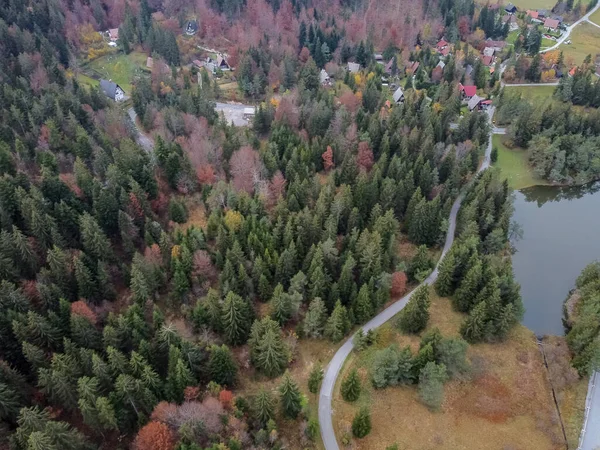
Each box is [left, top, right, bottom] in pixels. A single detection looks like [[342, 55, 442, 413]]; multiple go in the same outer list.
[[319, 107, 494, 450]]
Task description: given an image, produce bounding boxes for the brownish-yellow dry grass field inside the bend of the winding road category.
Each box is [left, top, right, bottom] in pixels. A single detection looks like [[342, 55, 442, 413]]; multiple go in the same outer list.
[[333, 296, 564, 450]]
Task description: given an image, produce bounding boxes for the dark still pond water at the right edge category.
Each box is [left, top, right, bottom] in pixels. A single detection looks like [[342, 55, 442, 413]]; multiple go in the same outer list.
[[513, 183, 600, 335]]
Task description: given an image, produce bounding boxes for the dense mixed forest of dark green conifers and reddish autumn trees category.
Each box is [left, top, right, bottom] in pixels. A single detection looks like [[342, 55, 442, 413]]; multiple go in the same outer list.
[[0, 0, 600, 450]]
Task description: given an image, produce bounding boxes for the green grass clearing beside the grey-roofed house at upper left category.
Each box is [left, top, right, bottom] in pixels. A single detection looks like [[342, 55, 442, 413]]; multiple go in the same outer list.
[[84, 52, 147, 94]]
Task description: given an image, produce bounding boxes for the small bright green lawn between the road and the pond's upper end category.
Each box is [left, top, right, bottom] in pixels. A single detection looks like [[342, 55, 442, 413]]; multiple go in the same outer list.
[[492, 134, 548, 189]]
